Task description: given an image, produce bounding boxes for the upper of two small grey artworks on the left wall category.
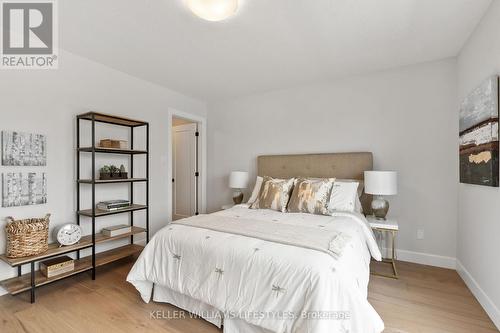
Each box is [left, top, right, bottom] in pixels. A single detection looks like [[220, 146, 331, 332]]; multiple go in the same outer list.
[[2, 131, 47, 166]]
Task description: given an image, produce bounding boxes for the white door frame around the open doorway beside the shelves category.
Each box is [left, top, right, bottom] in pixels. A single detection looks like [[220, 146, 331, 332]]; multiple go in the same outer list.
[[167, 108, 207, 222]]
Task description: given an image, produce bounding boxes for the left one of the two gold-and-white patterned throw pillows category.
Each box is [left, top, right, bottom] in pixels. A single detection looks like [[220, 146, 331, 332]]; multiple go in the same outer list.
[[250, 176, 295, 213]]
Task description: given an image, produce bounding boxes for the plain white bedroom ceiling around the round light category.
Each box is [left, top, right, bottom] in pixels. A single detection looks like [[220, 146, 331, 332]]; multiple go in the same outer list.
[[59, 0, 491, 101]]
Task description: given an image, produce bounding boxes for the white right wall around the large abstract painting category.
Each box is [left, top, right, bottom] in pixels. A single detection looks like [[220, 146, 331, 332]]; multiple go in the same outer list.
[[457, 1, 500, 328]]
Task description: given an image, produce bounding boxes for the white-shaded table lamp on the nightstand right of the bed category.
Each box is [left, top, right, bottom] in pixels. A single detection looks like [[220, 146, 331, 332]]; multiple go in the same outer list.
[[365, 171, 398, 220]]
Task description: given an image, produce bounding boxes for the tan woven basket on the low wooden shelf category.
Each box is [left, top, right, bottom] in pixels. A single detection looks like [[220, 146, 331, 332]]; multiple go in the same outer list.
[[5, 214, 50, 258]]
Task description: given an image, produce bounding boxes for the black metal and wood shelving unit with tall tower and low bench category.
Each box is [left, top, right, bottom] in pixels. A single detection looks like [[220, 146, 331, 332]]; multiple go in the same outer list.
[[0, 112, 149, 303]]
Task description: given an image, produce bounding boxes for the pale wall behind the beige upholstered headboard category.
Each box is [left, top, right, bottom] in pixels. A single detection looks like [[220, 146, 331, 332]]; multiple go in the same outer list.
[[208, 59, 458, 267]]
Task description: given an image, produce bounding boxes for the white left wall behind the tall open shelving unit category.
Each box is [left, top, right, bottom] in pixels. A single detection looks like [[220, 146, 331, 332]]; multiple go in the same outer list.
[[0, 52, 206, 293]]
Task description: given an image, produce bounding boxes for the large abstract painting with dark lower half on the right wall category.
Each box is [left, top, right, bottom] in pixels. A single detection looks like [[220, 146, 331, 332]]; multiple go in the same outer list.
[[459, 75, 499, 187]]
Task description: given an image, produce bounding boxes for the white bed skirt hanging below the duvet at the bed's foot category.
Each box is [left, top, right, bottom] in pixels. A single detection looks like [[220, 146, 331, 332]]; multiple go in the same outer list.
[[153, 284, 273, 333]]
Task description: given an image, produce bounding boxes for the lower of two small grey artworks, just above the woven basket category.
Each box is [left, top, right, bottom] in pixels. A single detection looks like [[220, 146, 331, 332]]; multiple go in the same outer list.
[[2, 172, 47, 207]]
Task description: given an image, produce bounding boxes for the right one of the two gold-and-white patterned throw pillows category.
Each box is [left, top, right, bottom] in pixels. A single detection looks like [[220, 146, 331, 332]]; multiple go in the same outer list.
[[288, 178, 335, 215]]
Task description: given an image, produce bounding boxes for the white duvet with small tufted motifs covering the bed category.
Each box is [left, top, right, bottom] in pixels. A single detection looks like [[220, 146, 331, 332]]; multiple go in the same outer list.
[[127, 205, 384, 333]]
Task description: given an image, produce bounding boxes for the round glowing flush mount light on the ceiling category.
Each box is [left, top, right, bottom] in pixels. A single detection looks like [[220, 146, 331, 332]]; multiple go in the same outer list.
[[186, 0, 238, 21]]
